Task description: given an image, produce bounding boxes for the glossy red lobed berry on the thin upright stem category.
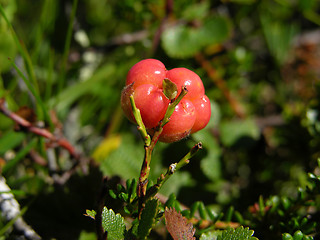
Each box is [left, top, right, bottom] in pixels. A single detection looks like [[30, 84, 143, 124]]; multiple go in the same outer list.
[[121, 59, 211, 142]]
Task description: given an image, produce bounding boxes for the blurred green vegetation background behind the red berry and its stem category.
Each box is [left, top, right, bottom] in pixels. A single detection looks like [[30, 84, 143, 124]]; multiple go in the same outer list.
[[0, 0, 320, 239]]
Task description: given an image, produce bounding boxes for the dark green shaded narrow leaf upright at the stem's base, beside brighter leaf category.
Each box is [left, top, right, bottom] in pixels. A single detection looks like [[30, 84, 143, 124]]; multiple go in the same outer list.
[[138, 198, 159, 239]]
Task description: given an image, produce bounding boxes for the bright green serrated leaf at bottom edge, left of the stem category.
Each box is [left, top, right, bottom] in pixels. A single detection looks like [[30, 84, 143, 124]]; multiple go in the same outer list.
[[102, 207, 125, 240]]
